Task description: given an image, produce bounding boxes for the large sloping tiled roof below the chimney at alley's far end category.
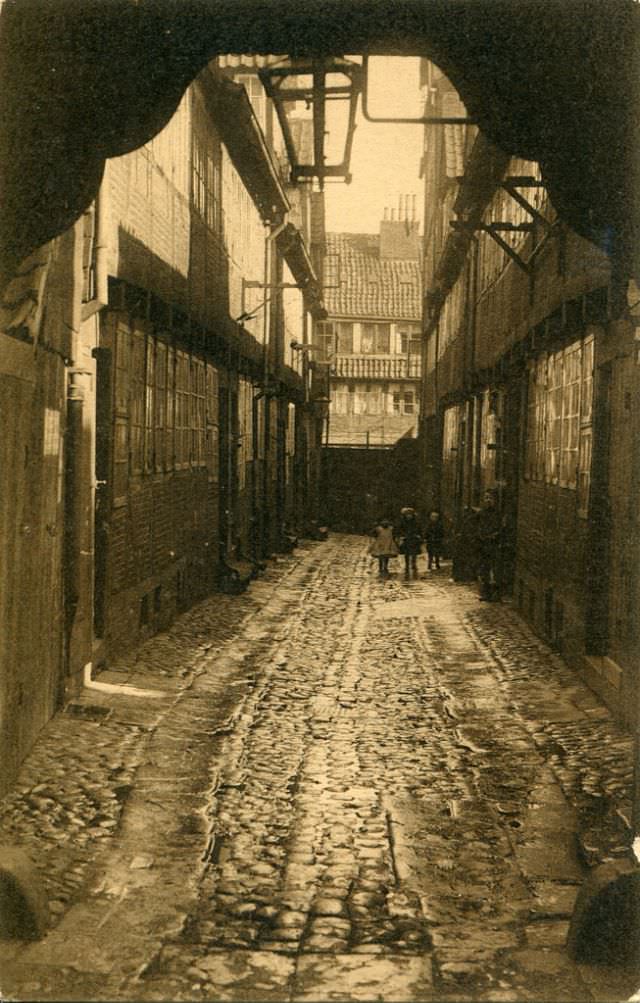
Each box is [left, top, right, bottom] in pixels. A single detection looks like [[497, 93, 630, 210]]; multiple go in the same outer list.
[[324, 234, 421, 321]]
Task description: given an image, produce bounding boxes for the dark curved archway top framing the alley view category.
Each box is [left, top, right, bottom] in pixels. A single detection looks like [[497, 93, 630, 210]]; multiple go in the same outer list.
[[0, 0, 640, 288]]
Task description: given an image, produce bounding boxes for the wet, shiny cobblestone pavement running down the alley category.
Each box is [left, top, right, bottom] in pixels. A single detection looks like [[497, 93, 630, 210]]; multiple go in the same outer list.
[[0, 537, 640, 1001]]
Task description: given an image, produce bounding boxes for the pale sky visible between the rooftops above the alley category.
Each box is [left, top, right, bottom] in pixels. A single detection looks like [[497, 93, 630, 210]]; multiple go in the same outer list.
[[325, 58, 423, 234]]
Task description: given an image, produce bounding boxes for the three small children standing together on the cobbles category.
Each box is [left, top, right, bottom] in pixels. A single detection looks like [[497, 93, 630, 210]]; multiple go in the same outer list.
[[369, 507, 444, 578]]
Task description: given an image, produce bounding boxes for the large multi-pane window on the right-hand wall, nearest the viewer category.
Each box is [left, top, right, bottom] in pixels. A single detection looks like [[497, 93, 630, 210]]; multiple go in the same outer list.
[[525, 335, 594, 505]]
